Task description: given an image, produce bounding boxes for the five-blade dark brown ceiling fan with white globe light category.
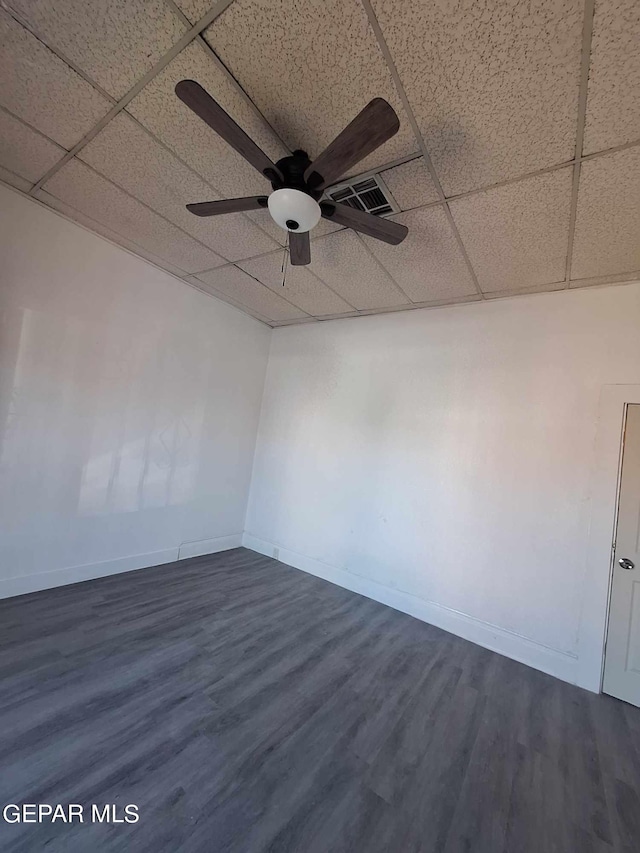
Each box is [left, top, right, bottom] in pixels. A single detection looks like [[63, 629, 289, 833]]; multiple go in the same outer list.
[[176, 80, 407, 266]]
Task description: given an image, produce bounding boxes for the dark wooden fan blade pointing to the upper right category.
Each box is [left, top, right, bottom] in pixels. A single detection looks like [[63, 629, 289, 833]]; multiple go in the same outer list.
[[304, 98, 400, 189]]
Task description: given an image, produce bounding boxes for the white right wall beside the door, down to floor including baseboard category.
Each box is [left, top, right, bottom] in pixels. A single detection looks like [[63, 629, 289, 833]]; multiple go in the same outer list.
[[244, 284, 640, 689]]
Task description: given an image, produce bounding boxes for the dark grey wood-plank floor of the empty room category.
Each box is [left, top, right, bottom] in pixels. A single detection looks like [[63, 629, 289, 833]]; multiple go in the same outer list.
[[0, 549, 640, 853]]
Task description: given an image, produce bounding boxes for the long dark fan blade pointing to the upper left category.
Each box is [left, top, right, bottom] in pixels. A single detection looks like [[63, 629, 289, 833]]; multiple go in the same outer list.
[[176, 80, 283, 181]]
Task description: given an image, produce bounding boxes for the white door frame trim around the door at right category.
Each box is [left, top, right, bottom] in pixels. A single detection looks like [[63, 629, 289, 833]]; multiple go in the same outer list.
[[576, 385, 640, 693]]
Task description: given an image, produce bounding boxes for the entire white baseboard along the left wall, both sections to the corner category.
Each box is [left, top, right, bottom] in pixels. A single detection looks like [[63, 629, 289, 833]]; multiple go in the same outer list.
[[0, 533, 242, 598]]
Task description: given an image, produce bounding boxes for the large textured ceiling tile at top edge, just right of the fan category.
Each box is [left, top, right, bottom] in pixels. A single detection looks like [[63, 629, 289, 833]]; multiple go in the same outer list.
[[372, 0, 584, 195]]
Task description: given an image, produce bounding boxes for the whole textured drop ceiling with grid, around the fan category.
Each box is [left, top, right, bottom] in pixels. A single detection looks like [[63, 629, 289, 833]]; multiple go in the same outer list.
[[0, 0, 640, 326]]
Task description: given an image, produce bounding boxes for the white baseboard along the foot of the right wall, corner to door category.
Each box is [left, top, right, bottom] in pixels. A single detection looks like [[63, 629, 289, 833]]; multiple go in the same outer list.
[[242, 533, 589, 689]]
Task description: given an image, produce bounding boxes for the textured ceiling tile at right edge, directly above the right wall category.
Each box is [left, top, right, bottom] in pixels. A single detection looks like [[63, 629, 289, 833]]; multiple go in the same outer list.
[[571, 146, 640, 279]]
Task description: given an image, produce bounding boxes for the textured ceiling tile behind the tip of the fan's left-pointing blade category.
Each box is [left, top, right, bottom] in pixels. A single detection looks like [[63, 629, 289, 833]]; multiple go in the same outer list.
[[78, 113, 276, 261]]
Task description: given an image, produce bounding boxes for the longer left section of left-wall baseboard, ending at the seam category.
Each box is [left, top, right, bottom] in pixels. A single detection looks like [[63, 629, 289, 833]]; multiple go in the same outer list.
[[0, 548, 179, 598]]
